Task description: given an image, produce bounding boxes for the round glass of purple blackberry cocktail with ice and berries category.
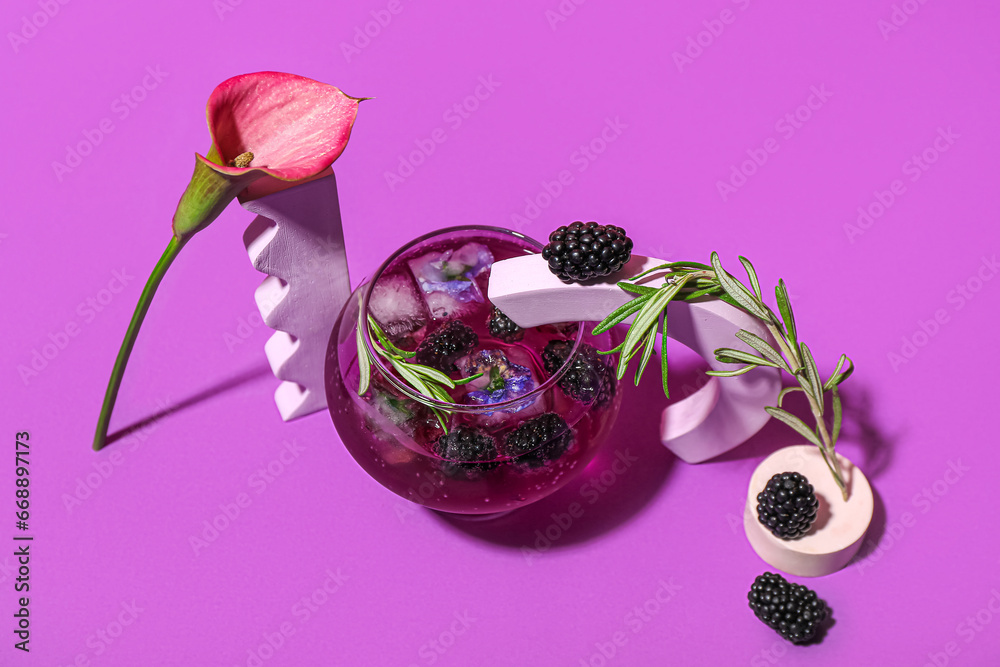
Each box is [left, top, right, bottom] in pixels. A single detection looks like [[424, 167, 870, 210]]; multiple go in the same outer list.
[[326, 227, 619, 514]]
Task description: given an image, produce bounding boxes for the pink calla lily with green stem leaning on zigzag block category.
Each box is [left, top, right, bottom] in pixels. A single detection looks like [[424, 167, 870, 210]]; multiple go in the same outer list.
[[94, 72, 368, 450]]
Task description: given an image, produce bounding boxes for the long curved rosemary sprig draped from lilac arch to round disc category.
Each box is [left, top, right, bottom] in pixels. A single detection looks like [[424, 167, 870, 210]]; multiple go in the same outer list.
[[594, 252, 854, 500]]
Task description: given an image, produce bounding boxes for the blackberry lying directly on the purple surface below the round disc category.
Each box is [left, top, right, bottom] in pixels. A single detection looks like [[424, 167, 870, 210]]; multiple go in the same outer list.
[[747, 572, 830, 644]]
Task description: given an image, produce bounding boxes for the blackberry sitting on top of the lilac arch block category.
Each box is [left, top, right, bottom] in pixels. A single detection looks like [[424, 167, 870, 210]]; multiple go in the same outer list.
[[542, 222, 632, 283]]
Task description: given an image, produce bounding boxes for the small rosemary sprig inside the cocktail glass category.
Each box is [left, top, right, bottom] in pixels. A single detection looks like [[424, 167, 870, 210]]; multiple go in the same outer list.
[[356, 300, 482, 433]]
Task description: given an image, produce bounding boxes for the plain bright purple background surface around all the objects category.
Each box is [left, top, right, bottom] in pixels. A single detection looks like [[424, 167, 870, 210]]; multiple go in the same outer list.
[[0, 0, 1000, 666]]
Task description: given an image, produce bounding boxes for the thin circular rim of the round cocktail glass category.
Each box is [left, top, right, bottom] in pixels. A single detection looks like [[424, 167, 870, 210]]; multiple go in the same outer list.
[[358, 225, 585, 414]]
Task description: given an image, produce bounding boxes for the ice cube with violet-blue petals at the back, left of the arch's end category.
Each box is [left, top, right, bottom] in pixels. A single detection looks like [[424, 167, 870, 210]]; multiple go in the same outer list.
[[407, 243, 493, 319]]
